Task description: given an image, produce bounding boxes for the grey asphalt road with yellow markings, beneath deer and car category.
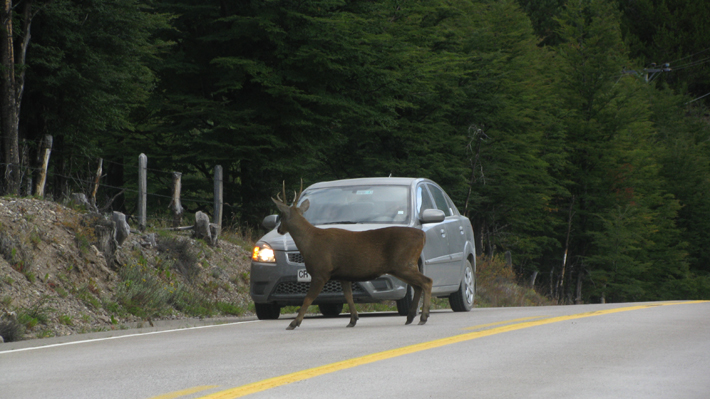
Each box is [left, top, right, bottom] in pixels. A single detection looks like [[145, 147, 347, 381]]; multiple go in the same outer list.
[[0, 302, 710, 399]]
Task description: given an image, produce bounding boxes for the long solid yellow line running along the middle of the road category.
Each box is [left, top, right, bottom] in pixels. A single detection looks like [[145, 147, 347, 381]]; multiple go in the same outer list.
[[199, 301, 708, 399]]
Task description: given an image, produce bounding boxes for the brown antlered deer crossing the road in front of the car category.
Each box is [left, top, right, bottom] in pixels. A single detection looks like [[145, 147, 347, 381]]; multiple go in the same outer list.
[[271, 181, 433, 330]]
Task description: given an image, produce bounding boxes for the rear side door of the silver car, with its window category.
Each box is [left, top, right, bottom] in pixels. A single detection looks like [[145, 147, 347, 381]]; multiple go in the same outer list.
[[428, 184, 466, 285]]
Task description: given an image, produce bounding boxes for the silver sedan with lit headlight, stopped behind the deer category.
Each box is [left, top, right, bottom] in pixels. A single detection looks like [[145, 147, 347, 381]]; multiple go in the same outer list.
[[251, 177, 476, 320]]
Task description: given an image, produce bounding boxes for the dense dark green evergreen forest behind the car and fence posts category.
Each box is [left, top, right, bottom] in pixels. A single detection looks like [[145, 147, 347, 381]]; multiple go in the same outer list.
[[0, 0, 710, 303]]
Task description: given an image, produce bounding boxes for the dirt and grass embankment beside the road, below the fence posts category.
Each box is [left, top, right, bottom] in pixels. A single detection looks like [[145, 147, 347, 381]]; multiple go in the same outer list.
[[0, 198, 250, 341]]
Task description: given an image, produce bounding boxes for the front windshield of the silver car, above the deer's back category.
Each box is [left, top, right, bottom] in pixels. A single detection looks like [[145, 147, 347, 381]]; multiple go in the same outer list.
[[301, 185, 410, 225]]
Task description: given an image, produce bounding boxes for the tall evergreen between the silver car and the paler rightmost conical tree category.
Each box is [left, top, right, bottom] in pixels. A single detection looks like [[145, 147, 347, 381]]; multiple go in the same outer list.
[[466, 1, 564, 271]]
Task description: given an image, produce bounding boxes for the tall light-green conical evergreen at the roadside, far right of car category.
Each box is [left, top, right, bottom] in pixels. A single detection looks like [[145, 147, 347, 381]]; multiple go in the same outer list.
[[558, 0, 685, 301]]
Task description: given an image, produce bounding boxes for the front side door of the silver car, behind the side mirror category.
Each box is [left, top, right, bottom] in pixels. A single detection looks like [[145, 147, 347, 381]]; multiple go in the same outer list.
[[415, 183, 451, 291]]
